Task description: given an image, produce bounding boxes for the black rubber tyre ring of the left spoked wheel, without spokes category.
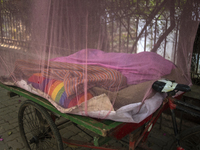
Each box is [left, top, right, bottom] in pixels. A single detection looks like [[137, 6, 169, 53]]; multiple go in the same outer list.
[[18, 100, 64, 150]]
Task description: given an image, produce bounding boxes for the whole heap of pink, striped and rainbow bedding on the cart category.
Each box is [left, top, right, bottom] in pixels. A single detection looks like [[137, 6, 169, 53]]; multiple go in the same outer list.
[[0, 49, 188, 123]]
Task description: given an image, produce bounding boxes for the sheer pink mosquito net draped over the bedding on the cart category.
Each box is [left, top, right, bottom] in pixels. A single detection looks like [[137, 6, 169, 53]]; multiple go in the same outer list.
[[0, 0, 200, 122]]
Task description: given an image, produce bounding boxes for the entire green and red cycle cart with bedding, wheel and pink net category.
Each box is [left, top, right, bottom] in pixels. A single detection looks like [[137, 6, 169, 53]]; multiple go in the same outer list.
[[0, 0, 200, 149]]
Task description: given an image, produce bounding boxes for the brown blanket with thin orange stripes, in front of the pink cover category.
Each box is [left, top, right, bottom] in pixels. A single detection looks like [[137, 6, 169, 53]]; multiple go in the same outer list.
[[13, 60, 127, 99]]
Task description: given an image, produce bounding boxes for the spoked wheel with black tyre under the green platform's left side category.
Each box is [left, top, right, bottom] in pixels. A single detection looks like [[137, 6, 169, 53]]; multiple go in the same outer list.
[[18, 100, 64, 150]]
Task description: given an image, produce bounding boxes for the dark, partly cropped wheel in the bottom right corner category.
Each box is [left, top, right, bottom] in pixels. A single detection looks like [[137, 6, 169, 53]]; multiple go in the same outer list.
[[167, 126, 200, 150]]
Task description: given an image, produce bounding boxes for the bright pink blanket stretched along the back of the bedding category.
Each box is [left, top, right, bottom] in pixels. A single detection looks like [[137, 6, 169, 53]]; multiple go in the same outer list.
[[51, 49, 175, 85]]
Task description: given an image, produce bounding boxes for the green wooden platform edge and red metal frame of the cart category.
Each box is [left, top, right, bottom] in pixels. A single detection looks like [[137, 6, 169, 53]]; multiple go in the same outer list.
[[0, 83, 200, 150]]
